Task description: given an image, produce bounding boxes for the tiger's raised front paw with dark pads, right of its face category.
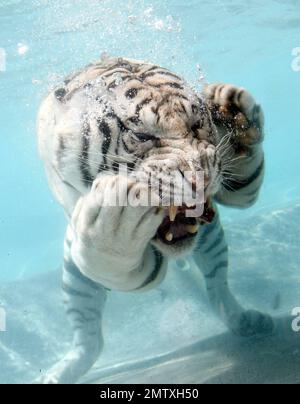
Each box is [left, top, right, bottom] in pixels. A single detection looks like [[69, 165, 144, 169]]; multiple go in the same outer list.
[[203, 84, 264, 154]]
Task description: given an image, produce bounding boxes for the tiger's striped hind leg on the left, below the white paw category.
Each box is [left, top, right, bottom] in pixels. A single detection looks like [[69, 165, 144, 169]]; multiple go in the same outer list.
[[37, 232, 107, 384]]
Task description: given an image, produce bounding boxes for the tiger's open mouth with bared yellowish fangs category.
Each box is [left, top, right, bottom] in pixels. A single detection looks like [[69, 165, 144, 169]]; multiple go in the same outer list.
[[157, 200, 215, 246]]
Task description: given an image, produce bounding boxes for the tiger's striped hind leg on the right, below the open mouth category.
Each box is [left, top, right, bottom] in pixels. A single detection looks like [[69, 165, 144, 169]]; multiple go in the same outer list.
[[194, 208, 274, 337]]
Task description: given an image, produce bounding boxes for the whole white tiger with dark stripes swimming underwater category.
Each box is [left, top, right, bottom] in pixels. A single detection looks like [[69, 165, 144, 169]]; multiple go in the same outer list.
[[38, 58, 274, 383]]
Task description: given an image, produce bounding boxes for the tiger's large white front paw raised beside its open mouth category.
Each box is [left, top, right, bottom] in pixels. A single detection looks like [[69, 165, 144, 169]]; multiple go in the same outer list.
[[71, 176, 163, 283]]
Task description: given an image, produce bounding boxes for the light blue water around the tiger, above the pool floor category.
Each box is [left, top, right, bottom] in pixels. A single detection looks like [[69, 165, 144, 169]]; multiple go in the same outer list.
[[0, 0, 300, 386]]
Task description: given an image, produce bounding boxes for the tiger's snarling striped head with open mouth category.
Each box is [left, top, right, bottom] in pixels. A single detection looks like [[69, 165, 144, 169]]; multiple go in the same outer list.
[[76, 59, 226, 256]]
